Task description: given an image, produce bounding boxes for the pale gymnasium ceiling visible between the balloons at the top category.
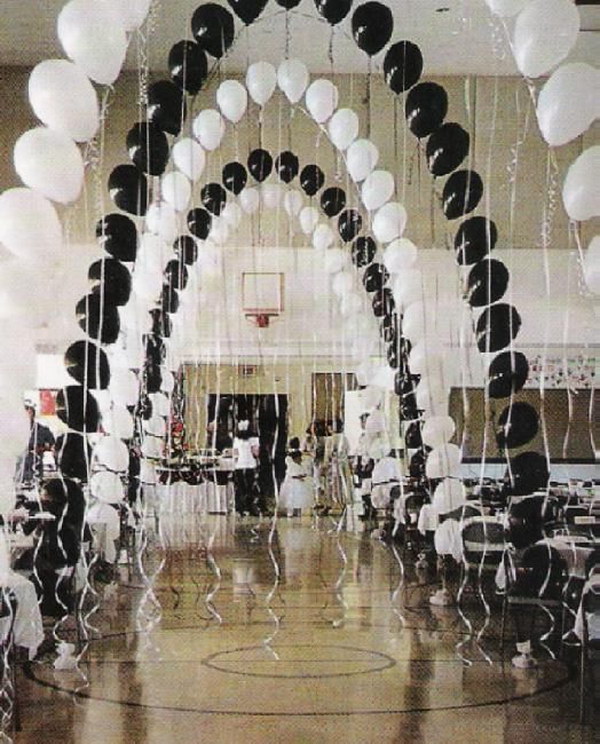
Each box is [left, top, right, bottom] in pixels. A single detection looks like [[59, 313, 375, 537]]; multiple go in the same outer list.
[[0, 0, 600, 75]]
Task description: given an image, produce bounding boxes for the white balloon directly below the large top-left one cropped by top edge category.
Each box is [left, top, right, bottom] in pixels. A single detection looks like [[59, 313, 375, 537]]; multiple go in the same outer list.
[[28, 59, 100, 142]]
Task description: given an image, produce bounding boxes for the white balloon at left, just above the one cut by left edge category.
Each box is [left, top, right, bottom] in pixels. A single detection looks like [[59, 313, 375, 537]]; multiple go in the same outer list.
[[14, 127, 83, 204]]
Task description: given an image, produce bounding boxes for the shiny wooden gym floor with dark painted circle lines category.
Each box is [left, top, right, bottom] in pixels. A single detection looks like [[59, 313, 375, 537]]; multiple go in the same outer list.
[[14, 514, 600, 744]]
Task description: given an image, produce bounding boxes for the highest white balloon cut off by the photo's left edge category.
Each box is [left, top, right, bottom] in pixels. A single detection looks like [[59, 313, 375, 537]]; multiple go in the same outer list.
[[0, 188, 62, 261]]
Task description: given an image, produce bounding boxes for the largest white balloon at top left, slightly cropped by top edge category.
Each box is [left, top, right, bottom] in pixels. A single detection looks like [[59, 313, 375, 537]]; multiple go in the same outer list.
[[56, 0, 127, 85]]
